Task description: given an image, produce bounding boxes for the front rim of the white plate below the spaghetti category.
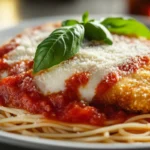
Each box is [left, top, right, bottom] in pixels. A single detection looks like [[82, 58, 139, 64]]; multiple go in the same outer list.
[[0, 131, 150, 150]]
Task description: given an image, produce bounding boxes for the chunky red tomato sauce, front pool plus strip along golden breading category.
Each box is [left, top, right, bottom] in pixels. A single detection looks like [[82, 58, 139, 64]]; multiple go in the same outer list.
[[0, 57, 149, 126]]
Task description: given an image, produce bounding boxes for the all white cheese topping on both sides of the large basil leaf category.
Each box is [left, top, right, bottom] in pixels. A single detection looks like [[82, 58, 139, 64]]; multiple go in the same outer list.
[[1, 25, 150, 102]]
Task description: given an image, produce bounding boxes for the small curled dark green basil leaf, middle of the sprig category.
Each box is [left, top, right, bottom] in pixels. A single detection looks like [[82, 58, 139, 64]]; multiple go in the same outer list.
[[84, 22, 112, 45]]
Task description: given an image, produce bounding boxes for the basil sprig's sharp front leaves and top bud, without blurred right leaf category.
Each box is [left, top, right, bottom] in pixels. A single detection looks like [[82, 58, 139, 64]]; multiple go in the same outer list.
[[33, 12, 112, 73]]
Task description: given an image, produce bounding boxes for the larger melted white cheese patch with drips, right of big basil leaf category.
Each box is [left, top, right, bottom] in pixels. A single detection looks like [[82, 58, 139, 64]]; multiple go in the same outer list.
[[34, 35, 150, 101]]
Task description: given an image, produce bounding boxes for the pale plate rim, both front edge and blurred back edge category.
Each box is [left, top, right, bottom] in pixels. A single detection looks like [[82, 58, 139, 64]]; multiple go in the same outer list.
[[0, 14, 150, 150]]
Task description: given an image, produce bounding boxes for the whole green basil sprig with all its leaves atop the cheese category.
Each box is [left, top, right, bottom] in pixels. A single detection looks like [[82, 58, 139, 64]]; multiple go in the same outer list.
[[33, 12, 150, 73]]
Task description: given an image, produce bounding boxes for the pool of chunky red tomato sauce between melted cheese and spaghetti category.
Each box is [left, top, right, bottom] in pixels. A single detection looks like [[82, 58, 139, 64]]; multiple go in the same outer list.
[[0, 71, 130, 125]]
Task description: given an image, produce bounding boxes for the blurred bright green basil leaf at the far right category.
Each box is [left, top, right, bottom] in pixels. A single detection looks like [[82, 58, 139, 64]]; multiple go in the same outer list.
[[101, 17, 150, 38]]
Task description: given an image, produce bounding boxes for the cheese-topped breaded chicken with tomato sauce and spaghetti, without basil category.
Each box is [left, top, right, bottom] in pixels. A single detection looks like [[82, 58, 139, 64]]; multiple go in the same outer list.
[[0, 14, 150, 143]]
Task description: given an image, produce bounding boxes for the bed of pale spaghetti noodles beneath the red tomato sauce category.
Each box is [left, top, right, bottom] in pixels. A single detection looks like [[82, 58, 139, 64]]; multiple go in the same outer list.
[[0, 106, 150, 143]]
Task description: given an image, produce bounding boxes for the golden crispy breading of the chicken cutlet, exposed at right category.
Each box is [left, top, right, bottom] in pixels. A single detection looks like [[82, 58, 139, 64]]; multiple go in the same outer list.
[[102, 65, 150, 113]]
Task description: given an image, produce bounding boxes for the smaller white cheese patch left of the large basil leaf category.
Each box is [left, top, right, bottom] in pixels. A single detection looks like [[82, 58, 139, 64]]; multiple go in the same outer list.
[[4, 25, 55, 64]]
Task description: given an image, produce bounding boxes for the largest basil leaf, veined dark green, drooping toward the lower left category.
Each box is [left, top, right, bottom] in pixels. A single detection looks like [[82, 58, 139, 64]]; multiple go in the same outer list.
[[33, 24, 84, 73]]
